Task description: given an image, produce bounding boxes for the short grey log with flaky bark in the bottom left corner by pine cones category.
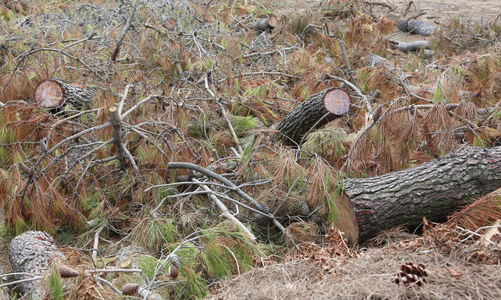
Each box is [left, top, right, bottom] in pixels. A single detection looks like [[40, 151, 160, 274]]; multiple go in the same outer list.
[[8, 231, 64, 299]]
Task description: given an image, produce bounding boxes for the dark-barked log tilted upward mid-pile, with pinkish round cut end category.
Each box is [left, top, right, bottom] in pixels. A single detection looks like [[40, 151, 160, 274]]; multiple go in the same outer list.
[[277, 88, 351, 145]]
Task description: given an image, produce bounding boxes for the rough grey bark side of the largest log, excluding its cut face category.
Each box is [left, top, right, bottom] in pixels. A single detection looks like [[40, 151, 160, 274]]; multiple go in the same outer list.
[[344, 147, 501, 241]]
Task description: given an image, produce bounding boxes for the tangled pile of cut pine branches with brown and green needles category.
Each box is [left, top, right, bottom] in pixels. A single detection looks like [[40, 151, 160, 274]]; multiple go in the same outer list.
[[0, 0, 501, 299]]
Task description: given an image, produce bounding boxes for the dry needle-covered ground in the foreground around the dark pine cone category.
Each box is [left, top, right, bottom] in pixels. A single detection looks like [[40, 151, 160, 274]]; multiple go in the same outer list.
[[210, 249, 501, 300]]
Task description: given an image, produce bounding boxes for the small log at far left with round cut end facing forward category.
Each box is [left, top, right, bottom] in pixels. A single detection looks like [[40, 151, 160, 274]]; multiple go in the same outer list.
[[35, 79, 94, 110]]
